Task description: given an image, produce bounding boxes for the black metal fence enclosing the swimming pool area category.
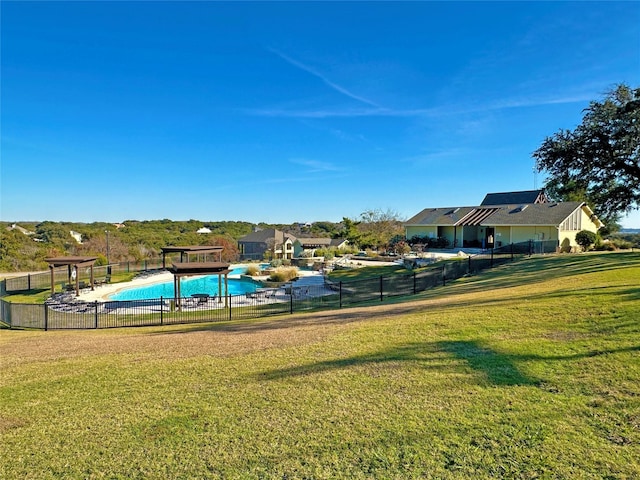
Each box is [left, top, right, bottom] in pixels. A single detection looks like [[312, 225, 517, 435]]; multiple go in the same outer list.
[[0, 242, 533, 330]]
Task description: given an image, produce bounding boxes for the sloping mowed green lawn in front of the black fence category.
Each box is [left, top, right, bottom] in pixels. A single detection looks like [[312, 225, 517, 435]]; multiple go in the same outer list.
[[0, 253, 640, 479]]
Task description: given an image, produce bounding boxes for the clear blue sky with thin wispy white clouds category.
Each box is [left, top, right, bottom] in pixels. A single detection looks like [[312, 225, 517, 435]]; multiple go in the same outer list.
[[0, 1, 640, 228]]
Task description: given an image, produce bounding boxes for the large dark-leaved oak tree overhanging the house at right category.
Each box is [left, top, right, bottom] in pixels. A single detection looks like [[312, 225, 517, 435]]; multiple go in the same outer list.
[[533, 84, 640, 226]]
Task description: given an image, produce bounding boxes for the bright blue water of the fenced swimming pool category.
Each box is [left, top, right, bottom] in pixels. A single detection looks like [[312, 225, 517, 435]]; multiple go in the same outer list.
[[109, 267, 258, 300]]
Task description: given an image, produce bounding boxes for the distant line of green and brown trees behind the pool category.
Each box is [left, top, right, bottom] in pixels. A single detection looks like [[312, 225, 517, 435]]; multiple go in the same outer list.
[[0, 210, 403, 272]]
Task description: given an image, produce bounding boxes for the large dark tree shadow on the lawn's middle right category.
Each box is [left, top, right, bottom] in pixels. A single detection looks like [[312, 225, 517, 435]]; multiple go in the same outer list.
[[257, 341, 540, 386]]
